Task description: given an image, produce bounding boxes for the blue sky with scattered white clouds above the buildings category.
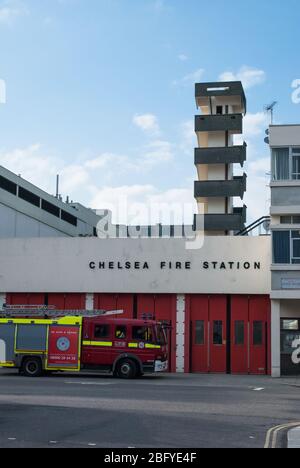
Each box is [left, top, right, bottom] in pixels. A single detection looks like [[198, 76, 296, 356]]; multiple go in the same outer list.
[[0, 0, 300, 222]]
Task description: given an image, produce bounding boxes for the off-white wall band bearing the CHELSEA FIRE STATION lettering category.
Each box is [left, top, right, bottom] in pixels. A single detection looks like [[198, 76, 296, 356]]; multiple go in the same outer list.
[[0, 237, 271, 294]]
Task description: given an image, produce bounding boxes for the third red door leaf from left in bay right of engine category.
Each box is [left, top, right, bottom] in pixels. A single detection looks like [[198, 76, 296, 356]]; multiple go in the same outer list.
[[231, 296, 249, 374]]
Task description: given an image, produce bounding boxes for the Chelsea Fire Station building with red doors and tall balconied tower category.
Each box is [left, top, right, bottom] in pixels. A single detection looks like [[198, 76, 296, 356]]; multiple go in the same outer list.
[[0, 82, 300, 376]]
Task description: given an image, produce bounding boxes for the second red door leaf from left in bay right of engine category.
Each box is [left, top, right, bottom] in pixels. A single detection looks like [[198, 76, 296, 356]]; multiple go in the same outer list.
[[209, 296, 227, 373]]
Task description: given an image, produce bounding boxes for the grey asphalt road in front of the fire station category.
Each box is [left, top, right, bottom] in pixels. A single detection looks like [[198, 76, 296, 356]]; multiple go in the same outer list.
[[0, 370, 300, 449]]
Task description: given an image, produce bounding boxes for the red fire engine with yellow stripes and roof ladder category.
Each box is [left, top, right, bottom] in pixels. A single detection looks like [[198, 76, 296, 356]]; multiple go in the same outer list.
[[0, 306, 168, 379]]
